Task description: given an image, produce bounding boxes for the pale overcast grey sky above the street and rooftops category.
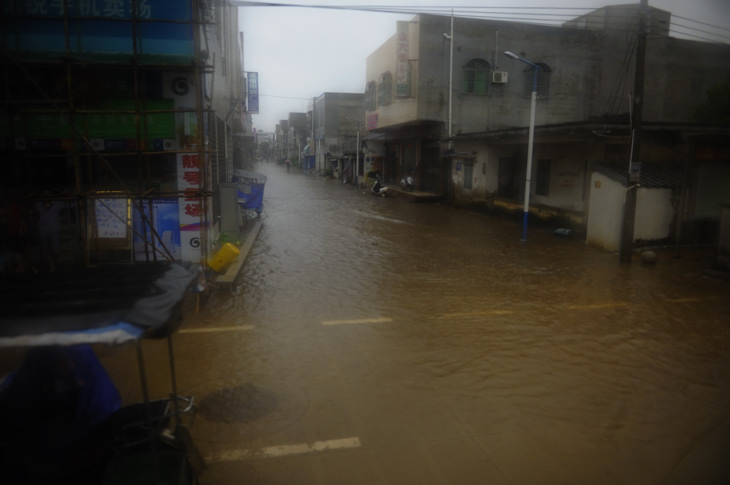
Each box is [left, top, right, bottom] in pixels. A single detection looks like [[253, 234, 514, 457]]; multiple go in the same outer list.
[[238, 0, 730, 131]]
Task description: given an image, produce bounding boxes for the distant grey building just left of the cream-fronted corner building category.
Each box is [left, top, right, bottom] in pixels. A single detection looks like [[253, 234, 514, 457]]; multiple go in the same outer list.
[[312, 93, 365, 183]]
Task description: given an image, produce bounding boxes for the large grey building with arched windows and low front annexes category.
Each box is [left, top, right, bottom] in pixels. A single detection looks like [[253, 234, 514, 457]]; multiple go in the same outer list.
[[365, 5, 730, 249]]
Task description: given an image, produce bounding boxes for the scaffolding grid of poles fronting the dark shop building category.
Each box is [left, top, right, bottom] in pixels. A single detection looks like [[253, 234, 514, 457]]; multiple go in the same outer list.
[[0, 0, 245, 266]]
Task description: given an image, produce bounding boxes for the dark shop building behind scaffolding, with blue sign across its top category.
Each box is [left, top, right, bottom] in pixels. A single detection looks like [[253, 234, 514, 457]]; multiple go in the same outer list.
[[0, 0, 252, 265]]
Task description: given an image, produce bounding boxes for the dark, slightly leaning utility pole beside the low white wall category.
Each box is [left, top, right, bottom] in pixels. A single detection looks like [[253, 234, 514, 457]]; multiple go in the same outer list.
[[619, 0, 649, 263]]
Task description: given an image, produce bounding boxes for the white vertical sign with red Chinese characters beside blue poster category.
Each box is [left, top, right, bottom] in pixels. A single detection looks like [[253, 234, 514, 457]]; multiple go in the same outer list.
[[177, 153, 203, 261]]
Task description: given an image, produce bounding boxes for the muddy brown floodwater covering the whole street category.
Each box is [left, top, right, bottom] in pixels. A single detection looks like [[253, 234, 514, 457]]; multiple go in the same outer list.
[[122, 165, 730, 485]]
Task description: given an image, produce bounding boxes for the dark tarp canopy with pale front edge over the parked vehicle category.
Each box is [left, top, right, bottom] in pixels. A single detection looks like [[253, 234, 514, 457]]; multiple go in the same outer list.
[[0, 262, 200, 347]]
